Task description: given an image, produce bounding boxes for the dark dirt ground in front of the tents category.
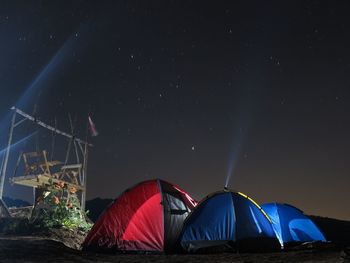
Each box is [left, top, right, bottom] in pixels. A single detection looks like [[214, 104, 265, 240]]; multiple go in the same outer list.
[[0, 236, 350, 263]]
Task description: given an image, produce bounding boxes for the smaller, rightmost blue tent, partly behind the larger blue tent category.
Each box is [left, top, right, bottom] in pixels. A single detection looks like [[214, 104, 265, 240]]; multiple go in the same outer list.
[[262, 203, 326, 249]]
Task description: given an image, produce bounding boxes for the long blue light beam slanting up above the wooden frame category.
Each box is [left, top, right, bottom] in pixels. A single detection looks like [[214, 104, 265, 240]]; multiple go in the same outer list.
[[0, 35, 74, 130]]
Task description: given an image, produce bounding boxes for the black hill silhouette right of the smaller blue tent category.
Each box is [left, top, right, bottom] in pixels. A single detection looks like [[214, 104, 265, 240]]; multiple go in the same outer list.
[[310, 216, 350, 246]]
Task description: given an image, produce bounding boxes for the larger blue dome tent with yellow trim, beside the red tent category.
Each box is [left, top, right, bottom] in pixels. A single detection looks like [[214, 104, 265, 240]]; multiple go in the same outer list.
[[180, 191, 280, 252]]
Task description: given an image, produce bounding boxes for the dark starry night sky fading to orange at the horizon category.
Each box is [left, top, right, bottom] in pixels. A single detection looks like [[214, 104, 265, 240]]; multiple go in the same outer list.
[[0, 0, 350, 220]]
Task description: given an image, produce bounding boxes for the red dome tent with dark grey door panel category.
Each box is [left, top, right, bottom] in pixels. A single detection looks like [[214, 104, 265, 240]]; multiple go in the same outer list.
[[83, 179, 197, 252]]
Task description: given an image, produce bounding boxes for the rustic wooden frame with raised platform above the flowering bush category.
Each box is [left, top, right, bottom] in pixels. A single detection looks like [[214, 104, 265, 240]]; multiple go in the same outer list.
[[0, 107, 92, 216]]
